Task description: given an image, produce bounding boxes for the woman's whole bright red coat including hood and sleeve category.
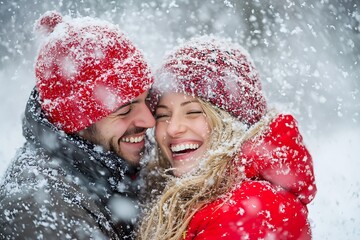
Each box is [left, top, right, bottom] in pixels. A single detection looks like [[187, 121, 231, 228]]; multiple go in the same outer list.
[[183, 115, 316, 240]]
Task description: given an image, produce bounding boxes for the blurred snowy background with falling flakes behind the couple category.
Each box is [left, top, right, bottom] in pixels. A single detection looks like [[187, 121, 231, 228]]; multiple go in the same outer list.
[[0, 0, 360, 240]]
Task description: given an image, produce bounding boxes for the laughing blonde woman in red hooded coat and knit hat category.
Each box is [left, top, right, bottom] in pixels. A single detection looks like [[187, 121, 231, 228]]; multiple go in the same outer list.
[[139, 37, 316, 240]]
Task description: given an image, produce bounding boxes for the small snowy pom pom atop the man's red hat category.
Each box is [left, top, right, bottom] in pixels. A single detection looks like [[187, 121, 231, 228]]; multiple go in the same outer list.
[[35, 11, 62, 34]]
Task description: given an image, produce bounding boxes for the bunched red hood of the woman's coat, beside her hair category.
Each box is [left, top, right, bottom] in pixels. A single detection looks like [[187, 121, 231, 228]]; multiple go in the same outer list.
[[240, 115, 316, 204]]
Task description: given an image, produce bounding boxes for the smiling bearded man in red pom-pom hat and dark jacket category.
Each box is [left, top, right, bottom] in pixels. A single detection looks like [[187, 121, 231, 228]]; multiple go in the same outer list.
[[0, 12, 155, 239]]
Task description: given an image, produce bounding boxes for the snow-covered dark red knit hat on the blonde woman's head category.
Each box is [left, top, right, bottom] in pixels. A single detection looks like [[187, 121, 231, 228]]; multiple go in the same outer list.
[[154, 37, 266, 125]]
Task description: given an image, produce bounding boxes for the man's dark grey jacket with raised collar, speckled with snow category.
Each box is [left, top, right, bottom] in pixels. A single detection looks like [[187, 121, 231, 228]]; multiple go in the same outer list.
[[0, 89, 140, 239]]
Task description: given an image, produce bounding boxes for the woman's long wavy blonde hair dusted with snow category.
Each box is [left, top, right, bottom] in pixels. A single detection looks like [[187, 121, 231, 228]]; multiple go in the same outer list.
[[138, 99, 270, 240]]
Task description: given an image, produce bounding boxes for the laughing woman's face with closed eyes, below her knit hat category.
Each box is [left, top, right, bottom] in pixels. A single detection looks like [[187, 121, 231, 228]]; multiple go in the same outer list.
[[155, 93, 211, 177]]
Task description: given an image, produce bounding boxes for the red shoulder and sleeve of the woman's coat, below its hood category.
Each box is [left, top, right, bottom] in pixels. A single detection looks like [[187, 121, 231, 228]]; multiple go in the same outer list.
[[183, 181, 311, 240]]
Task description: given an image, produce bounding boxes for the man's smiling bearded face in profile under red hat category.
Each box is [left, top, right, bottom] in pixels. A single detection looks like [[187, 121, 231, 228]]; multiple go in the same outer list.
[[80, 92, 155, 165]]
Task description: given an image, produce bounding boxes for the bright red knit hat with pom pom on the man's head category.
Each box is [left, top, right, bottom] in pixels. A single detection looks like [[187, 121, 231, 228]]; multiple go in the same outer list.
[[35, 12, 153, 133]]
